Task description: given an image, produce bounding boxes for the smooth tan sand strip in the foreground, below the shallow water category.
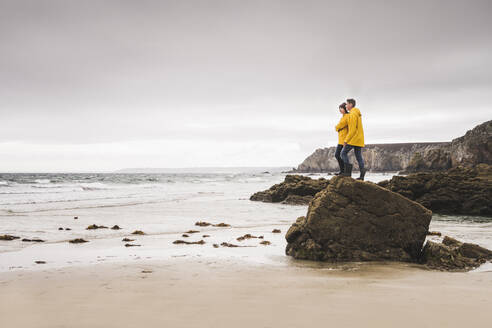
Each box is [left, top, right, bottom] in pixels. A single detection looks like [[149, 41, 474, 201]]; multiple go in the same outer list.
[[0, 258, 492, 328]]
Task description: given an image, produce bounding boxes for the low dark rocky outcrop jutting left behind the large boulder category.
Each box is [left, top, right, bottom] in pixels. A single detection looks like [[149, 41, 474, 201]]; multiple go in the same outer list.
[[250, 175, 330, 205]]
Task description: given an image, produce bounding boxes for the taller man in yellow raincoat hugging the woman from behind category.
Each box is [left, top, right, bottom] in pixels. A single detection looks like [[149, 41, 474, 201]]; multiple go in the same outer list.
[[341, 99, 367, 180]]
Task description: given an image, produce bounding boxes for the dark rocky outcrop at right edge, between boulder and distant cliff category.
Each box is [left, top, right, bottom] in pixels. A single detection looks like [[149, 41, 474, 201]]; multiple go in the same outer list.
[[379, 164, 492, 216]]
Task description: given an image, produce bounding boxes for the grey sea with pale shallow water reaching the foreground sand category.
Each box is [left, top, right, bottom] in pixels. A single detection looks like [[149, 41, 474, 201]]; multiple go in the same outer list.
[[0, 168, 492, 272]]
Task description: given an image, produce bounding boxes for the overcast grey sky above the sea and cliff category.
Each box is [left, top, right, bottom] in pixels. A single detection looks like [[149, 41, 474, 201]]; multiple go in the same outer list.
[[0, 0, 492, 172]]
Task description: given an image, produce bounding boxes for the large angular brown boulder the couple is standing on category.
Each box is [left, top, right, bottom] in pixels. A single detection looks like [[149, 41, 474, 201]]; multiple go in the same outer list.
[[285, 176, 432, 262]]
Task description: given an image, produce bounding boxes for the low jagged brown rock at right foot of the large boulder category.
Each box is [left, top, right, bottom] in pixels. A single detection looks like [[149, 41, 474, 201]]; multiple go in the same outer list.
[[422, 236, 492, 271]]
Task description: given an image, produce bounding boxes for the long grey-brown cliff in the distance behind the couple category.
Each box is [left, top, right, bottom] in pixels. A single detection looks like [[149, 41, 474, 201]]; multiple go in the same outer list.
[[293, 121, 492, 172]]
